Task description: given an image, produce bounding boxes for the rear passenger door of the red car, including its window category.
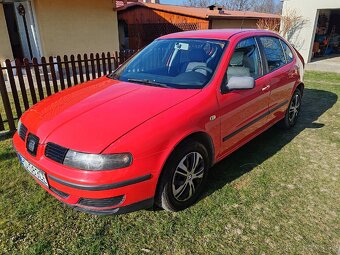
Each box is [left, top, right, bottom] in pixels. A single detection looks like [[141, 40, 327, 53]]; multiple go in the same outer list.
[[258, 36, 298, 122]]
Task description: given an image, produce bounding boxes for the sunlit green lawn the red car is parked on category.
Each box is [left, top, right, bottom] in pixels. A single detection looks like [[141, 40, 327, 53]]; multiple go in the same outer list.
[[0, 72, 340, 254]]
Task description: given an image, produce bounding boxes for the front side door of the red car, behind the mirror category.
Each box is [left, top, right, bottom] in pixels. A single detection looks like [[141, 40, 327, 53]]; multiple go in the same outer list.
[[218, 37, 269, 155]]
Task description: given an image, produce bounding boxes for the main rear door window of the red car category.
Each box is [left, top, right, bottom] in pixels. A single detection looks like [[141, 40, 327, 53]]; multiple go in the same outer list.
[[260, 37, 286, 72]]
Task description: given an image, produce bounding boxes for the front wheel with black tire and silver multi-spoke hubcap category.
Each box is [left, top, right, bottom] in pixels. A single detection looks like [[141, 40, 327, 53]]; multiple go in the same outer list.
[[155, 141, 210, 212]]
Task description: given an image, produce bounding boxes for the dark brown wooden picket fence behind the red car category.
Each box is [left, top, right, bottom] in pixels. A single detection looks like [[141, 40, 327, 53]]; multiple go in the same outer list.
[[0, 51, 133, 131]]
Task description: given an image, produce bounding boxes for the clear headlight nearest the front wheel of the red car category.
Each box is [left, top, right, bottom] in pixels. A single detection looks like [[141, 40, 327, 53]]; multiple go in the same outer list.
[[64, 150, 132, 171]]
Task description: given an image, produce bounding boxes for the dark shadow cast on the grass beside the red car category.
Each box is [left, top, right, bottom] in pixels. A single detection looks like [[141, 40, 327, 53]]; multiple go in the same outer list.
[[201, 89, 338, 199]]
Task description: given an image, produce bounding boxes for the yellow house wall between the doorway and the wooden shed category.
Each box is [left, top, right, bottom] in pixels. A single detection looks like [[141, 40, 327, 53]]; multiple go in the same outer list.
[[33, 0, 119, 56]]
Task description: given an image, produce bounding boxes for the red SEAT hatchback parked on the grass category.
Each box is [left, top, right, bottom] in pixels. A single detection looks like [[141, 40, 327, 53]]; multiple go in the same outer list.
[[13, 29, 304, 215]]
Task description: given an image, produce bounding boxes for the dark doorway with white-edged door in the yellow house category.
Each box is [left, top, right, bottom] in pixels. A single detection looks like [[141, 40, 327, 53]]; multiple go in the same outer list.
[[3, 1, 41, 60]]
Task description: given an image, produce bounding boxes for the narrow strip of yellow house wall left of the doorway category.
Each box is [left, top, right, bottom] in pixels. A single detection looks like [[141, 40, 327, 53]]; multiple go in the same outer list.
[[0, 4, 13, 63]]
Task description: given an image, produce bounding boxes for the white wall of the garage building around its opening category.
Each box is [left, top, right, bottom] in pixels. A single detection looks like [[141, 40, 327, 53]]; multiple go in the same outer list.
[[282, 0, 340, 62]]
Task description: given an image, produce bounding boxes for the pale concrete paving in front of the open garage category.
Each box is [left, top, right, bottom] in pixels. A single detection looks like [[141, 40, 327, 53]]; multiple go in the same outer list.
[[305, 55, 340, 73]]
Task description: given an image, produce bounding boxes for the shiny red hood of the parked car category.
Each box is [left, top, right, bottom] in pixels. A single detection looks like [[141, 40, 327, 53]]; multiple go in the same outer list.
[[22, 77, 200, 153]]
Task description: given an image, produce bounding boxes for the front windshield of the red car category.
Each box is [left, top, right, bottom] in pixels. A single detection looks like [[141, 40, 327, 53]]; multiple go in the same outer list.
[[109, 39, 227, 89]]
